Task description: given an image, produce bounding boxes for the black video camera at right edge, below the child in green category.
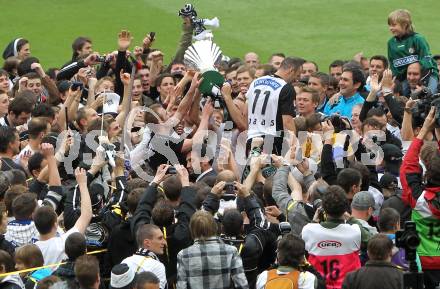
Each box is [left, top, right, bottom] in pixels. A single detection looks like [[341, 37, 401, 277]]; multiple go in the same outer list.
[[411, 87, 440, 127]]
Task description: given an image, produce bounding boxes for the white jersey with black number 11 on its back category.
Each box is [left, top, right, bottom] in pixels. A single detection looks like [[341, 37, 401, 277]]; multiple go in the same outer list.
[[246, 76, 286, 139]]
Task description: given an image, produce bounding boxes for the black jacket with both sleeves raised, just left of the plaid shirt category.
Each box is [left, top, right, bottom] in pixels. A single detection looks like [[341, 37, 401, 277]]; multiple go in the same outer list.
[[131, 183, 197, 284]]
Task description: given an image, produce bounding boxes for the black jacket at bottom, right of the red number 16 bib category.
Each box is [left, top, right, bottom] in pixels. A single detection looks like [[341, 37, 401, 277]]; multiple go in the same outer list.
[[342, 261, 403, 289]]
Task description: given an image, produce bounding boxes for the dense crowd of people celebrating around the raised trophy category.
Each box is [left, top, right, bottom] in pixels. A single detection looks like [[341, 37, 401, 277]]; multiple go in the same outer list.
[[0, 10, 440, 289]]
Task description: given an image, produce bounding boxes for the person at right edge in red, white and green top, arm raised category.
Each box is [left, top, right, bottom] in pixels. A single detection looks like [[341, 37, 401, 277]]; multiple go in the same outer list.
[[400, 107, 440, 288]]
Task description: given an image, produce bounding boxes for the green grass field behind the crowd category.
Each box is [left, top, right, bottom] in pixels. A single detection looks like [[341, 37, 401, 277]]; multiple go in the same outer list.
[[0, 0, 440, 71]]
